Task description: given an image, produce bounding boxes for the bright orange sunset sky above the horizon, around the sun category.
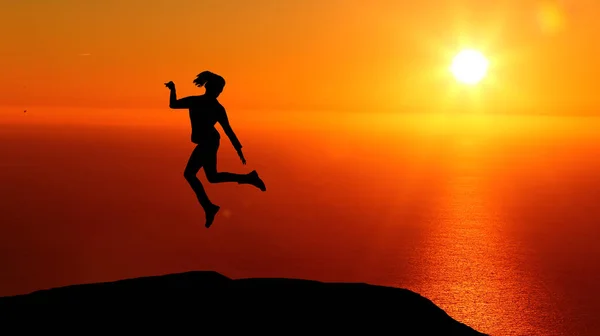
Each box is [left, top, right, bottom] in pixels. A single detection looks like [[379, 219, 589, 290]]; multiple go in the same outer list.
[[0, 0, 600, 112]]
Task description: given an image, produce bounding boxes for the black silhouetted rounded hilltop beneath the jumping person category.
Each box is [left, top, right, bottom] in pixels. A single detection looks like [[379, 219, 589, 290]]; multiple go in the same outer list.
[[0, 272, 484, 335]]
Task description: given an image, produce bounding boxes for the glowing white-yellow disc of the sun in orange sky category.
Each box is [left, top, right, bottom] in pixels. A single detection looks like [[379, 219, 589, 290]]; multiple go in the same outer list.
[[450, 49, 489, 85]]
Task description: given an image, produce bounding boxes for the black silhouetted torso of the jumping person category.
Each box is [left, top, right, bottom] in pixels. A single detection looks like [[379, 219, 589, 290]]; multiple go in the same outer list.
[[189, 96, 223, 143]]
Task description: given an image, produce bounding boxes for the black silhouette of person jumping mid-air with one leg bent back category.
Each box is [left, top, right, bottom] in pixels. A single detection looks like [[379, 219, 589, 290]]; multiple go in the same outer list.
[[165, 71, 266, 228]]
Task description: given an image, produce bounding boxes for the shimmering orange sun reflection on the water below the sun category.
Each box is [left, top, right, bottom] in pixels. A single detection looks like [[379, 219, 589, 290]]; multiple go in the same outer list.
[[404, 131, 568, 335]]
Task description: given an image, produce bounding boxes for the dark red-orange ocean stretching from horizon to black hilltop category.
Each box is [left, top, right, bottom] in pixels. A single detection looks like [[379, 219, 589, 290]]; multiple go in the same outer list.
[[0, 108, 600, 336]]
